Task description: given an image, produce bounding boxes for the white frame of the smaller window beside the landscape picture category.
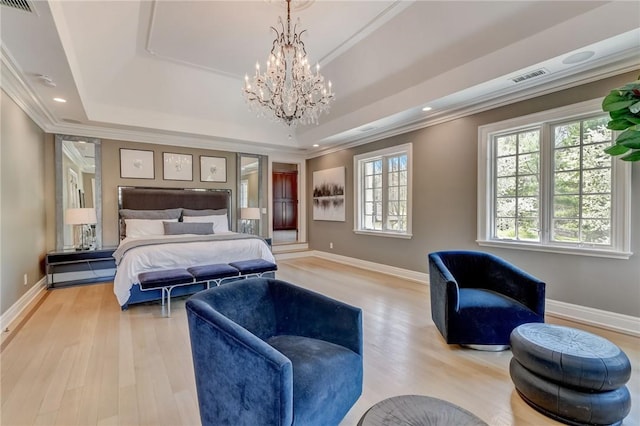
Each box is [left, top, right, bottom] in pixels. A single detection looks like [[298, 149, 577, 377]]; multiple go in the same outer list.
[[353, 143, 413, 239]]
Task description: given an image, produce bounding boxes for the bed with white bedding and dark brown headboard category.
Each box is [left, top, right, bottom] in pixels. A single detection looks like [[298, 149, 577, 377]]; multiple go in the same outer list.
[[114, 186, 275, 310]]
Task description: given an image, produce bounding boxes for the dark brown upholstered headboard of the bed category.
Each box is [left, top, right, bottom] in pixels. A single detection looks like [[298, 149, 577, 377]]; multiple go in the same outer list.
[[118, 186, 234, 240]]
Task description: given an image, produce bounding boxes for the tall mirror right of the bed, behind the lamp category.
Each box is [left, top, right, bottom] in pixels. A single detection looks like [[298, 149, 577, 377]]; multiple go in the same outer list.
[[237, 154, 266, 235]]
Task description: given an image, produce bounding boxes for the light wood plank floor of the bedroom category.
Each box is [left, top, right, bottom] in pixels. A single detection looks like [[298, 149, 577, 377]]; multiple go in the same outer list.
[[0, 257, 640, 426]]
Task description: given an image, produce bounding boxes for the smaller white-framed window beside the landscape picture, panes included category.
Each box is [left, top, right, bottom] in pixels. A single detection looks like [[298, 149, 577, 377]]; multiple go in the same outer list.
[[354, 144, 412, 238]]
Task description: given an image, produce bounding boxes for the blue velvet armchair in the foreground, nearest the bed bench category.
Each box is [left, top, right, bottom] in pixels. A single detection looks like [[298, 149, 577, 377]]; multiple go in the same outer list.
[[186, 278, 363, 426]]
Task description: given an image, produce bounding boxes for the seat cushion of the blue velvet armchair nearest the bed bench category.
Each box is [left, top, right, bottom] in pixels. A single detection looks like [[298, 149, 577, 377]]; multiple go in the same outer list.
[[266, 335, 363, 425]]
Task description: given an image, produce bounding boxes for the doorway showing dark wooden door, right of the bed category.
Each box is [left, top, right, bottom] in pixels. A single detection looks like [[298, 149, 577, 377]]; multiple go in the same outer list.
[[272, 163, 298, 244]]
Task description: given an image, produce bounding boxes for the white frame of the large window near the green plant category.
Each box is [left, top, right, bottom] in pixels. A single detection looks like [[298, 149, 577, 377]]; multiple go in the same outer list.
[[476, 99, 633, 259]]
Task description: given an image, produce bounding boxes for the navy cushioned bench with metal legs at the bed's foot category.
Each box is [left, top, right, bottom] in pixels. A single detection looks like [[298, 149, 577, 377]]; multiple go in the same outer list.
[[138, 259, 278, 317]]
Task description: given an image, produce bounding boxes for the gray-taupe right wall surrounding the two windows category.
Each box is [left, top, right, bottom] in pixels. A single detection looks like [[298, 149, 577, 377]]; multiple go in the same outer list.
[[306, 71, 640, 317]]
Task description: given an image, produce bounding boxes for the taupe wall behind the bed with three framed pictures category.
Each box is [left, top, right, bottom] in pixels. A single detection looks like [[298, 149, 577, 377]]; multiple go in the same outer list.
[[101, 139, 237, 247]]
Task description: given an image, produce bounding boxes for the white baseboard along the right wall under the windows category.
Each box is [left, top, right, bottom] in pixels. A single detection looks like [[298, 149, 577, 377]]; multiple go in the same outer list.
[[295, 250, 640, 337]]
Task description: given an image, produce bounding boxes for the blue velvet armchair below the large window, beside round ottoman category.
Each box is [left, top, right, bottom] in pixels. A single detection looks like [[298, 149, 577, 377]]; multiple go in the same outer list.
[[429, 251, 545, 350]]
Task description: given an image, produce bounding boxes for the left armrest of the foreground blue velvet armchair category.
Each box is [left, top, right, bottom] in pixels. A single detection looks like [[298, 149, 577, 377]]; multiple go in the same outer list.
[[186, 298, 293, 425]]
